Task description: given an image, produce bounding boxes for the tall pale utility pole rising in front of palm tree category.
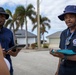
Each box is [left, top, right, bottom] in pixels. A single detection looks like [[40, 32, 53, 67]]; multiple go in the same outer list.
[[37, 0, 40, 49]]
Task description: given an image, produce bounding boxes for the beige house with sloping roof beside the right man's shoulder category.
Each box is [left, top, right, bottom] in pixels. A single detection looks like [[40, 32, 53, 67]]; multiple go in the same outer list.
[[46, 31, 61, 48]]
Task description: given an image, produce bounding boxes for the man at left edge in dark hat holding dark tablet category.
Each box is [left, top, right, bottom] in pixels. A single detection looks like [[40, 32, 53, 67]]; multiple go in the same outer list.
[[0, 7, 19, 75]]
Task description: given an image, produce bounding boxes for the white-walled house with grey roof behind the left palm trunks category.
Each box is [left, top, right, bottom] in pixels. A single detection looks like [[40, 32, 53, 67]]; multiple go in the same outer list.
[[15, 30, 37, 44]]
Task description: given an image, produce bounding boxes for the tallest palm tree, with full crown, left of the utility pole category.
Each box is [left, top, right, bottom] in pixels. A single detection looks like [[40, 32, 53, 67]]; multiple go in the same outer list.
[[16, 4, 36, 48]]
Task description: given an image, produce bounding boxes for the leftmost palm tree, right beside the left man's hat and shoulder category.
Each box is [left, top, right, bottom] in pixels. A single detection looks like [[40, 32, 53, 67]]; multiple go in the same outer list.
[[4, 9, 19, 44]]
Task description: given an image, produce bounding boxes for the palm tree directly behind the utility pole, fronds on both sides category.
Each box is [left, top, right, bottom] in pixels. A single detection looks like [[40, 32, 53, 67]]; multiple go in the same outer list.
[[32, 15, 51, 42]]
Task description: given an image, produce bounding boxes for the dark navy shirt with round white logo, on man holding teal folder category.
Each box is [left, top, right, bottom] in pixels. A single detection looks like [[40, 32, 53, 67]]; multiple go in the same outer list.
[[58, 29, 76, 75]]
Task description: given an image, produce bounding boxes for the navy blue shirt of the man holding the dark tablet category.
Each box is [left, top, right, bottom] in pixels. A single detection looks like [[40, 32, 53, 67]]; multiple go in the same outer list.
[[0, 27, 14, 72]]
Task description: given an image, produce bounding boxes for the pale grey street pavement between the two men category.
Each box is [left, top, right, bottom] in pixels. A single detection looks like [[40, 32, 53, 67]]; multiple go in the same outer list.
[[12, 51, 58, 75]]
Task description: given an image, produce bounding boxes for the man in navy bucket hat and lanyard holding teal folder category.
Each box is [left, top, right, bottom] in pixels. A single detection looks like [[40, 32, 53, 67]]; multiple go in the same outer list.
[[50, 5, 76, 75]]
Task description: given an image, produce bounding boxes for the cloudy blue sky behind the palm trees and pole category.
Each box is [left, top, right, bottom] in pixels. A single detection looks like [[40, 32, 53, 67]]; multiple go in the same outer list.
[[0, 0, 76, 37]]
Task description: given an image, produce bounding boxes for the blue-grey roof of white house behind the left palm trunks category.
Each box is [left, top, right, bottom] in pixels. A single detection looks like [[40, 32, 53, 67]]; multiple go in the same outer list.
[[15, 30, 37, 38]]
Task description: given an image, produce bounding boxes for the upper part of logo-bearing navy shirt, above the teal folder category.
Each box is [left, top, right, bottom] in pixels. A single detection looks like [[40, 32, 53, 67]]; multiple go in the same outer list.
[[59, 29, 76, 52]]
